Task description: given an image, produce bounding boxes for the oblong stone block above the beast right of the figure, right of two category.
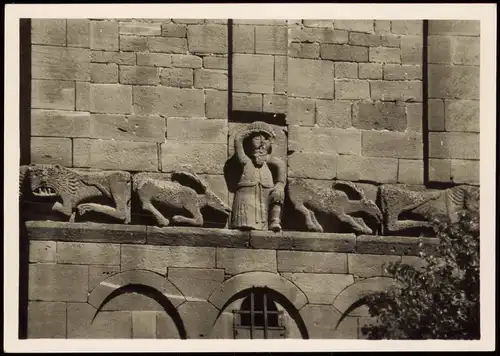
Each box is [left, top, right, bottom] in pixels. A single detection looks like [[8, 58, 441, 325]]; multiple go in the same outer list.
[[337, 155, 398, 183]]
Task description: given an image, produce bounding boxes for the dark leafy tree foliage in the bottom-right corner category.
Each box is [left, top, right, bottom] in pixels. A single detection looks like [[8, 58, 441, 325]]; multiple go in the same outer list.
[[362, 212, 480, 340]]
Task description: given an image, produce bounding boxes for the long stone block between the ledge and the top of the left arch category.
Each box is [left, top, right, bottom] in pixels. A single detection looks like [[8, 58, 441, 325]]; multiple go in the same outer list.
[[121, 245, 215, 275]]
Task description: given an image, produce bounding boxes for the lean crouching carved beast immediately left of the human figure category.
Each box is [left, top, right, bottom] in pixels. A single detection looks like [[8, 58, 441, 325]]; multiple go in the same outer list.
[[132, 172, 231, 226]]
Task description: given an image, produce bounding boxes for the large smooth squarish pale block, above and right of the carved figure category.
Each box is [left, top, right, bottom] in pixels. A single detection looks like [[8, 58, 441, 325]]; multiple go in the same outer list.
[[288, 58, 333, 99]]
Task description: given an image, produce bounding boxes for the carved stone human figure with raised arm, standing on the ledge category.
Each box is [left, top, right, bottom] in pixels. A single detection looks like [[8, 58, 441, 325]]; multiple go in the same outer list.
[[231, 121, 286, 231]]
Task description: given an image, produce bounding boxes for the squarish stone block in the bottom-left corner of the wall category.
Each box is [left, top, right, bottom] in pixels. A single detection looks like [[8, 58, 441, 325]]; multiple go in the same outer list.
[[28, 301, 66, 339]]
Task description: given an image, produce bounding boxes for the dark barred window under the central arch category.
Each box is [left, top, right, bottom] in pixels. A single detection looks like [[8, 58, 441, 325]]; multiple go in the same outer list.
[[233, 288, 286, 339]]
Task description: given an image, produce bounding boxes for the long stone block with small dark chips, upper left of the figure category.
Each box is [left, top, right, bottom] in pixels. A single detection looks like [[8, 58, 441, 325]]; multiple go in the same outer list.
[[90, 114, 165, 142]]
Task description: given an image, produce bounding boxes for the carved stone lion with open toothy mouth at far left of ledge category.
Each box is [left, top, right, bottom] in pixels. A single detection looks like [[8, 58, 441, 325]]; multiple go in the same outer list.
[[28, 164, 131, 224]]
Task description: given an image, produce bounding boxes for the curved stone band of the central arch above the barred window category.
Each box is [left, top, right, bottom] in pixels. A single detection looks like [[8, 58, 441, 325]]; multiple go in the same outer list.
[[208, 272, 307, 310]]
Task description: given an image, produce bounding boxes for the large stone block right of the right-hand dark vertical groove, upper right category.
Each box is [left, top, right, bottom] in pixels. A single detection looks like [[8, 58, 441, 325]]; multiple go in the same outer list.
[[429, 64, 479, 99]]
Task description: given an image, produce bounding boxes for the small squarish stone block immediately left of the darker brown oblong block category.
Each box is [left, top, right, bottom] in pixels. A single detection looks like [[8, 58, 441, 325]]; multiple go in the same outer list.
[[316, 100, 351, 128]]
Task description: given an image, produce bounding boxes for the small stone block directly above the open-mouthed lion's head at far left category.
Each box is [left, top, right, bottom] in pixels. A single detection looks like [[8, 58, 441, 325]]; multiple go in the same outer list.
[[31, 137, 72, 167]]
